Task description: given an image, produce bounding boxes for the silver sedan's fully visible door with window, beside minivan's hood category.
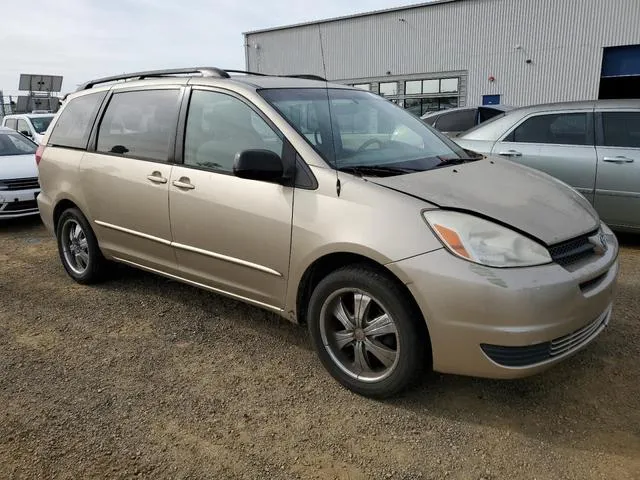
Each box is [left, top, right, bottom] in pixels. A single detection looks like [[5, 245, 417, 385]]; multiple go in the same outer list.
[[492, 111, 596, 203]]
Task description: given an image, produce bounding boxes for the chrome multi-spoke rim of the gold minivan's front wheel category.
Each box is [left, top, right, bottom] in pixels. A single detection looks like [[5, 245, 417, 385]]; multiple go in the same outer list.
[[320, 288, 400, 382]]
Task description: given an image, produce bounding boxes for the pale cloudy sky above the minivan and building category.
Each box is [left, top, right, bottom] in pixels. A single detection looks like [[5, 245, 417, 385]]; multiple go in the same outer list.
[[0, 0, 428, 95]]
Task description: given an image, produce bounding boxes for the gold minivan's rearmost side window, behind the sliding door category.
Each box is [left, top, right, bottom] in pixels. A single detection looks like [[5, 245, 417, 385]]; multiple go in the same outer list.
[[49, 92, 107, 149]]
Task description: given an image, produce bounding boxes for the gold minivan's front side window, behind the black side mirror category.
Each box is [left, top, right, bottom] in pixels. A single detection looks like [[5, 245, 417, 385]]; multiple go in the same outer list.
[[184, 90, 282, 172]]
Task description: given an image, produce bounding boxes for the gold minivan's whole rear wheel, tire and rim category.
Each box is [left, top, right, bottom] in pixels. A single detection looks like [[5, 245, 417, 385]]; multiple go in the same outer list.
[[56, 208, 106, 284]]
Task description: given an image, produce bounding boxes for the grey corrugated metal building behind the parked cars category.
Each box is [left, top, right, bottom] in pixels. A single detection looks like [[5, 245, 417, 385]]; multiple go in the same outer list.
[[244, 0, 640, 114]]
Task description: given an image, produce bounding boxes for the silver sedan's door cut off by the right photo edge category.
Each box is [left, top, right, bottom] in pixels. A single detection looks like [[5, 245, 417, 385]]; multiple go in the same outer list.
[[596, 110, 640, 228]]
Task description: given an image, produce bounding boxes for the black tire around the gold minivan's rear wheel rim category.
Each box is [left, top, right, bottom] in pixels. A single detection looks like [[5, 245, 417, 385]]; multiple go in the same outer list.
[[56, 208, 107, 285]]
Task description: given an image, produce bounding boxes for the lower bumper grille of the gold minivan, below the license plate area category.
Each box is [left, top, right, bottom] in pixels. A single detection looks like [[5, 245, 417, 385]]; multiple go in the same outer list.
[[480, 310, 610, 367]]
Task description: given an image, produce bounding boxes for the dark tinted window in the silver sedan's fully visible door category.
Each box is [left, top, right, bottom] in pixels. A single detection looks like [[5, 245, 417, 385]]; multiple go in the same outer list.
[[507, 113, 593, 145]]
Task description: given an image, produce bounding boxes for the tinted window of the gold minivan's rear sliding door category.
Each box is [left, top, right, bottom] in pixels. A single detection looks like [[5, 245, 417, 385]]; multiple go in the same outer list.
[[97, 90, 180, 162]]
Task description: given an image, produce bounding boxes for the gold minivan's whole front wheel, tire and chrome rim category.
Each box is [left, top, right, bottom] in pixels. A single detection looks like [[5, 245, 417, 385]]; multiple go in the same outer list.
[[307, 266, 430, 398]]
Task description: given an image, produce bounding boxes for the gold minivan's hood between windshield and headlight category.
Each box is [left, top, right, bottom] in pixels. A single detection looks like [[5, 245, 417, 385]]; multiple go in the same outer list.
[[370, 158, 600, 245]]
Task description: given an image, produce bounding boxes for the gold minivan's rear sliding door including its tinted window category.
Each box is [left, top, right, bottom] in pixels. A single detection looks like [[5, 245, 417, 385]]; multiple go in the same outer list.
[[80, 89, 180, 274]]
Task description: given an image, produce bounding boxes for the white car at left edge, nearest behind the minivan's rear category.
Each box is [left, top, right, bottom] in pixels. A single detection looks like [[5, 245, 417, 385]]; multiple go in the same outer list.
[[0, 127, 40, 220]]
